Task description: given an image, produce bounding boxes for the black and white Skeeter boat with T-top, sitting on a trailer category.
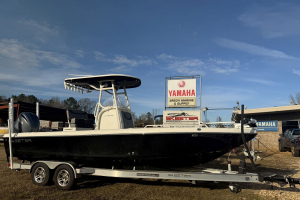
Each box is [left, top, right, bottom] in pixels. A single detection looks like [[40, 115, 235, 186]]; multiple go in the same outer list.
[[4, 74, 257, 167]]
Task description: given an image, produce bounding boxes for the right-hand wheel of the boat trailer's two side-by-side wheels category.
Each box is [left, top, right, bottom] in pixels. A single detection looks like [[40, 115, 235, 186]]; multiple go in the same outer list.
[[53, 165, 75, 190]]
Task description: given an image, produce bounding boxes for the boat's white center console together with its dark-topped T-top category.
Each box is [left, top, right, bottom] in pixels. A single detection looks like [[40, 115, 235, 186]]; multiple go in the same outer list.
[[65, 74, 141, 130]]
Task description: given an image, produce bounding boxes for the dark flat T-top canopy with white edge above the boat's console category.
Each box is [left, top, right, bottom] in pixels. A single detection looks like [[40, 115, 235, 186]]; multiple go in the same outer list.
[[65, 74, 141, 90]]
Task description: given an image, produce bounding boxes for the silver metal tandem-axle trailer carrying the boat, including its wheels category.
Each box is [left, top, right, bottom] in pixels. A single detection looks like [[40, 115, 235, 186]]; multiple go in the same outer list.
[[9, 154, 300, 193]]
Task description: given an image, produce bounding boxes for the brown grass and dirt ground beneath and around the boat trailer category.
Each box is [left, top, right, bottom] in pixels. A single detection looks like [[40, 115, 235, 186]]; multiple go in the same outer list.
[[0, 139, 300, 200]]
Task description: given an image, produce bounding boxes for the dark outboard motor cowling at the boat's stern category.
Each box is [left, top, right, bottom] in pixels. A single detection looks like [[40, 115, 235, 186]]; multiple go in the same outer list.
[[14, 112, 40, 133]]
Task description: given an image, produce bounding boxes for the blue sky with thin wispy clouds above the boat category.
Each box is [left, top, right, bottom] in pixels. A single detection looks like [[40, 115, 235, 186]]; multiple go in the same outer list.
[[0, 0, 300, 121]]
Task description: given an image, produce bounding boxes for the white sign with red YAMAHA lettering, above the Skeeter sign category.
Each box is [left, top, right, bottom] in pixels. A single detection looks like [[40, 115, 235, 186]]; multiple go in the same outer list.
[[168, 79, 196, 107]]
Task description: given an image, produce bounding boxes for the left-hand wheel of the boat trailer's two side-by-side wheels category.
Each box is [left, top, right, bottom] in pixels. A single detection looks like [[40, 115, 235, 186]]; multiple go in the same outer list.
[[31, 163, 50, 186]]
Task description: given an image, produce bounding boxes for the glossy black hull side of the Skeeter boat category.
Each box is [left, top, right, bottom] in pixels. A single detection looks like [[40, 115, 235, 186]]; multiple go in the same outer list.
[[4, 132, 256, 166]]
